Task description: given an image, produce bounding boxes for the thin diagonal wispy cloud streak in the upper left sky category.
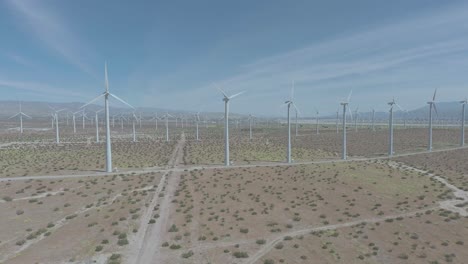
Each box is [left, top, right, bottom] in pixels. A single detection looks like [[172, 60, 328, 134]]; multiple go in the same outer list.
[[7, 0, 94, 75]]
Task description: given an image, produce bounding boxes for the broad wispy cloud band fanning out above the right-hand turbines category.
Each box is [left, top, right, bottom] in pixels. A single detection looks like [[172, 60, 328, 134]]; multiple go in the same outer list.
[[158, 2, 468, 113]]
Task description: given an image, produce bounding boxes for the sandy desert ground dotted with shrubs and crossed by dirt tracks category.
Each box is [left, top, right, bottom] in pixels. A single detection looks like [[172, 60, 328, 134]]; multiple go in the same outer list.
[[0, 122, 468, 264]]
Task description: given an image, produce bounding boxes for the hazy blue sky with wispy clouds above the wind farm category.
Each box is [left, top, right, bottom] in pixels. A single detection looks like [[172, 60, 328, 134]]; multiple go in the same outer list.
[[0, 0, 468, 116]]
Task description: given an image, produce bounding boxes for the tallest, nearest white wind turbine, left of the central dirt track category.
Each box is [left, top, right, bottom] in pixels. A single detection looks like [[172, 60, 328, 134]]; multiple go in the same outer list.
[[81, 63, 134, 172]]
